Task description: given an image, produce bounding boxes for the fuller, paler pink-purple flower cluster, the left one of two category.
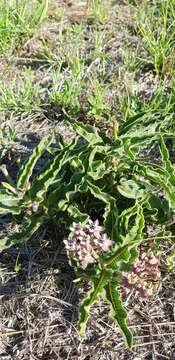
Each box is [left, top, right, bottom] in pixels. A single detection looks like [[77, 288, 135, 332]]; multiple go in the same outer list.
[[64, 220, 112, 269]]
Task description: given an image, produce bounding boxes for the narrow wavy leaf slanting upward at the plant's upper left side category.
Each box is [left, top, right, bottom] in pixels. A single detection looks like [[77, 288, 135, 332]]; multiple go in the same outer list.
[[17, 135, 52, 189]]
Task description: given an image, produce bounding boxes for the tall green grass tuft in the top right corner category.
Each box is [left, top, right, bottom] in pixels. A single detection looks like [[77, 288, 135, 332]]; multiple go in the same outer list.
[[136, 0, 175, 75]]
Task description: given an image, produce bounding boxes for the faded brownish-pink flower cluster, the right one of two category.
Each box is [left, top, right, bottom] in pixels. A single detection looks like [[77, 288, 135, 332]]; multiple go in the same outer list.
[[122, 252, 161, 299]]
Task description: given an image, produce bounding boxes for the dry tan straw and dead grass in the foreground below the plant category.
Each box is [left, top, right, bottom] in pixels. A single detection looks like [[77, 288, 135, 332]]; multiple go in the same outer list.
[[0, 229, 175, 360]]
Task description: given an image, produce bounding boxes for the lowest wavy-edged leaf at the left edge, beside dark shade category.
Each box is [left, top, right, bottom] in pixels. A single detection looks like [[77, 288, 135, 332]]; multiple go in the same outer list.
[[0, 215, 43, 250]]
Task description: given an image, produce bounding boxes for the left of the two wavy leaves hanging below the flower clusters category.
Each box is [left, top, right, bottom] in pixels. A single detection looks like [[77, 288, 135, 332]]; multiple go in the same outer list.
[[78, 272, 109, 336]]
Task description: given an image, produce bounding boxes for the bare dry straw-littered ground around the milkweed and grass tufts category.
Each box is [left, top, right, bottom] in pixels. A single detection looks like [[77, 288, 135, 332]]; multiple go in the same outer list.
[[0, 0, 175, 360]]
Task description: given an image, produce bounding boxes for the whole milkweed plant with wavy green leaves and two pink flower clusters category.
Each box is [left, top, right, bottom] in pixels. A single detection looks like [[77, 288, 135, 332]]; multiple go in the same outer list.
[[0, 114, 175, 347]]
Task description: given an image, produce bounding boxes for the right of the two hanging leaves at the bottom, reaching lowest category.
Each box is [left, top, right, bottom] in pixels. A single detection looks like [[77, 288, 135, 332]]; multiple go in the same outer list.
[[105, 281, 133, 348]]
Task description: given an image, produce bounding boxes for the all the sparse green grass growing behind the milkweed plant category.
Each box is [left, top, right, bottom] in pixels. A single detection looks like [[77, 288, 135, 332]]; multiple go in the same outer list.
[[0, 0, 175, 131]]
